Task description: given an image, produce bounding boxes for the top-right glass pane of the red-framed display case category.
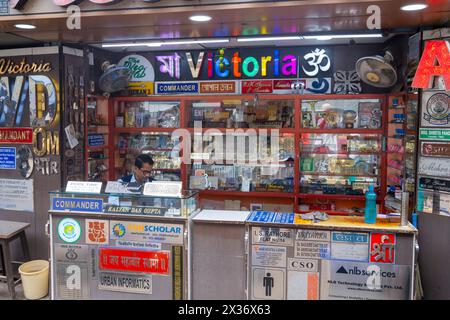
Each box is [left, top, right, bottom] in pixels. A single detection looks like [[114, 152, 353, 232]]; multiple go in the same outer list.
[[302, 99, 382, 129]]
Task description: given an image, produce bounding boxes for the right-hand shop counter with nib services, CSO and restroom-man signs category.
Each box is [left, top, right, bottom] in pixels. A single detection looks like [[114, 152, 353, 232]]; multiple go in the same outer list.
[[246, 212, 417, 300]]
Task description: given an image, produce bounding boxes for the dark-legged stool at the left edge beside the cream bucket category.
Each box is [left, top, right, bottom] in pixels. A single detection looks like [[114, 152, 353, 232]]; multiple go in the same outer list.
[[0, 220, 30, 299]]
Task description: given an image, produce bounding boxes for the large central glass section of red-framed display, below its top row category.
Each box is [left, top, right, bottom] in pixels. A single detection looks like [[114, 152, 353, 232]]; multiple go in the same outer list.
[[189, 132, 295, 192]]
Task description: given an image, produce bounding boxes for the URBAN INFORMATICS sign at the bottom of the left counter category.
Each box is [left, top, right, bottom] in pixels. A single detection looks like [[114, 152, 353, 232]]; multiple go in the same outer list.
[[98, 272, 153, 294]]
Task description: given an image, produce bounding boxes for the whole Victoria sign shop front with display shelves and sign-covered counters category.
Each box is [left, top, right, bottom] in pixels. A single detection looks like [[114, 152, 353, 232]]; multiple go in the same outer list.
[[0, 1, 448, 300]]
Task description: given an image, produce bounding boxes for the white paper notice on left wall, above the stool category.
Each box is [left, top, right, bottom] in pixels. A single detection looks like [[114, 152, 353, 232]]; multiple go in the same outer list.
[[0, 179, 34, 212]]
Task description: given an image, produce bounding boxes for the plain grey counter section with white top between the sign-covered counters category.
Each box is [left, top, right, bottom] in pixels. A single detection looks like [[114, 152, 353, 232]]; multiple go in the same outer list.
[[192, 210, 250, 300]]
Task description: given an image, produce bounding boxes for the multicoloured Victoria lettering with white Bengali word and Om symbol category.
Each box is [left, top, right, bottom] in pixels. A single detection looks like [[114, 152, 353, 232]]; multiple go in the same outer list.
[[156, 49, 331, 79]]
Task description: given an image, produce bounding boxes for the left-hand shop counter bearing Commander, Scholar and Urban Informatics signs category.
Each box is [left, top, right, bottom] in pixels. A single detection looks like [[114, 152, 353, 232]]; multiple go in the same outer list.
[[49, 192, 198, 300]]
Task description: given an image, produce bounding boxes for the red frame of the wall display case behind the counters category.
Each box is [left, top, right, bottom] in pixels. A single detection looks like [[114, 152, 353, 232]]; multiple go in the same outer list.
[[89, 94, 389, 215]]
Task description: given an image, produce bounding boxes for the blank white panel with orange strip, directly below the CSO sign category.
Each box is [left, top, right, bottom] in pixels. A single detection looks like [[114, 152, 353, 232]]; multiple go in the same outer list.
[[287, 271, 319, 300]]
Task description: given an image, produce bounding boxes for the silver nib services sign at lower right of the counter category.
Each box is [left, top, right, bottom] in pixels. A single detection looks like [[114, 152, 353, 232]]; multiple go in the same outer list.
[[320, 260, 411, 300]]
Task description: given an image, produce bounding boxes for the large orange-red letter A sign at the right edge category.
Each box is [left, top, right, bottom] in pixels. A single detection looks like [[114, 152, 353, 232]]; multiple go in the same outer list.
[[412, 40, 450, 90]]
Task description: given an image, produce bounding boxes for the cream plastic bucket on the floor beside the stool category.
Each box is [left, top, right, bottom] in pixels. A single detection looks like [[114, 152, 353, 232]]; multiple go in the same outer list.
[[19, 260, 49, 300]]
